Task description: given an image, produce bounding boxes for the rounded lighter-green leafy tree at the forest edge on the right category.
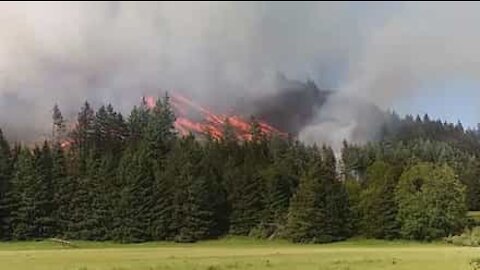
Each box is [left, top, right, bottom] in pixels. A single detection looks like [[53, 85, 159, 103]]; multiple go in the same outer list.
[[395, 163, 466, 240]]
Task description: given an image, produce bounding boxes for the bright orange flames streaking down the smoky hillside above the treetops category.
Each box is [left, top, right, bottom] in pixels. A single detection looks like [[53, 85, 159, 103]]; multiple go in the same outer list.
[[145, 94, 286, 140]]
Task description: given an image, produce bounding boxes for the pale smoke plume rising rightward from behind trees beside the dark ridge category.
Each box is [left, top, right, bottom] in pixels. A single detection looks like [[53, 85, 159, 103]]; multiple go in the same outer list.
[[300, 2, 480, 149]]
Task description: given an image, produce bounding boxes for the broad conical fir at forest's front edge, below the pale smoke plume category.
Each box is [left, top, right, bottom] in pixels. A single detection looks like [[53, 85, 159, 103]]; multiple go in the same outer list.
[[285, 147, 352, 243]]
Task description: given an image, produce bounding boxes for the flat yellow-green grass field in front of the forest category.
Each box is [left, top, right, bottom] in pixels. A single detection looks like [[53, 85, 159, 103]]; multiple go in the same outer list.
[[0, 238, 480, 270]]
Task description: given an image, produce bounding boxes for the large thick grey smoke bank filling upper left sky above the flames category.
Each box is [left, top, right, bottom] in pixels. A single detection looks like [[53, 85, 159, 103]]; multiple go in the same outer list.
[[0, 2, 368, 143]]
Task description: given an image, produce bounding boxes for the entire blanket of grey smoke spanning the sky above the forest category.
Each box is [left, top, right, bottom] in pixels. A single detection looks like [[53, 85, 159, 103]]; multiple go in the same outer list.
[[0, 2, 480, 145]]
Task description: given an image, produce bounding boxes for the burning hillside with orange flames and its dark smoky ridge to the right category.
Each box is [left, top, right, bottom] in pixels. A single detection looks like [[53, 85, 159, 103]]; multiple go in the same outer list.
[[142, 76, 330, 140]]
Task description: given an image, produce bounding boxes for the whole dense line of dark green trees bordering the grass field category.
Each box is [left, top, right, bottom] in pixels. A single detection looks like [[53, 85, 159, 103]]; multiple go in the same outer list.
[[0, 96, 474, 243]]
